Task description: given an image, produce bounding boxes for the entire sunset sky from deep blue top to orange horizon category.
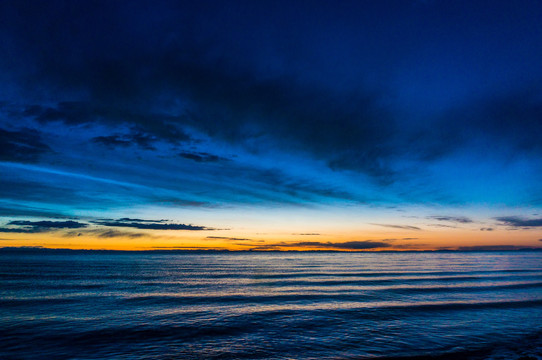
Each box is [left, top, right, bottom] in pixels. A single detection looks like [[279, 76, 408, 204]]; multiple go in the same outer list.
[[0, 0, 542, 251]]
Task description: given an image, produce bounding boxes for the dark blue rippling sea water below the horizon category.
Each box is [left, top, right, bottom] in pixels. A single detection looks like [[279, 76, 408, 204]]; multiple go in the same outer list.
[[0, 252, 542, 359]]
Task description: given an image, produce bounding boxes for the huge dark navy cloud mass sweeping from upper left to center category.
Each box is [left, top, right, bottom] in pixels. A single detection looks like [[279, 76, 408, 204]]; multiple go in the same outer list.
[[0, 2, 395, 181]]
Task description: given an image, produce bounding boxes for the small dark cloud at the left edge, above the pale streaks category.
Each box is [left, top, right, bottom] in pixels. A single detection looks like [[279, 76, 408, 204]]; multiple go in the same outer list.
[[0, 128, 51, 162]]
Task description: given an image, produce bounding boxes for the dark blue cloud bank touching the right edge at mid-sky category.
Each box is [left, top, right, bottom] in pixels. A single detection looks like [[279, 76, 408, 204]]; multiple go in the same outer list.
[[407, 85, 542, 162]]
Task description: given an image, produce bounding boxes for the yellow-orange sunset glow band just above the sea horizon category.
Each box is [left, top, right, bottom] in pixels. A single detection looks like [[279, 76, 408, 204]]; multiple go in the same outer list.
[[0, 226, 541, 251]]
